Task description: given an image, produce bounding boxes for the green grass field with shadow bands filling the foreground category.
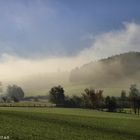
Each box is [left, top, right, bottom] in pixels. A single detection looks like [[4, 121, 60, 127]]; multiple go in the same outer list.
[[0, 107, 140, 140]]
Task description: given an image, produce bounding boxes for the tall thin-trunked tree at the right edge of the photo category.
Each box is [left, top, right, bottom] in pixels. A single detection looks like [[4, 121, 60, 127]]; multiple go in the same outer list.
[[129, 85, 140, 114]]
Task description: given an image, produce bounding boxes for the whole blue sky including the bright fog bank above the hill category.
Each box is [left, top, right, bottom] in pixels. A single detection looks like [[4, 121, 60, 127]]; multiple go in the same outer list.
[[0, 0, 140, 80]]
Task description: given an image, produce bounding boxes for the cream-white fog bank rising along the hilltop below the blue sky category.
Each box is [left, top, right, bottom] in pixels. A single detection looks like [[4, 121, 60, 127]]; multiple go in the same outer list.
[[0, 23, 140, 81]]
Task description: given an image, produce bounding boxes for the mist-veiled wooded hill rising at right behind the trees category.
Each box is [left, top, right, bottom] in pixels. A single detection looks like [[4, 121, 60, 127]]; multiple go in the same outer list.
[[70, 52, 140, 87]]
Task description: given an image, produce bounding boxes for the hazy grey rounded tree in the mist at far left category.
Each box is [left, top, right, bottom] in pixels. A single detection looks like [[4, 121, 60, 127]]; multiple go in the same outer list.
[[7, 85, 24, 102]]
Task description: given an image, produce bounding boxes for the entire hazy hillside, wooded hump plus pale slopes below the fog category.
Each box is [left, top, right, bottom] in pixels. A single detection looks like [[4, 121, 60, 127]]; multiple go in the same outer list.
[[3, 52, 140, 95]]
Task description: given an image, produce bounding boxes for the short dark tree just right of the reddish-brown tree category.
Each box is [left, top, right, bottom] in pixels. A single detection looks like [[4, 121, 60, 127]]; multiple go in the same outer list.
[[105, 96, 117, 112]]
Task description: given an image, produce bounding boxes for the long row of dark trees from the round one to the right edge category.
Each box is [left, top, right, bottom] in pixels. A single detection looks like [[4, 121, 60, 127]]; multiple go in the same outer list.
[[49, 85, 140, 114]]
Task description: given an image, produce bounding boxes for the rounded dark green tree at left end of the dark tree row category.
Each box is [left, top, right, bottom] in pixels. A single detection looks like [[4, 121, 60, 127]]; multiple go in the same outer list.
[[49, 85, 65, 106]]
